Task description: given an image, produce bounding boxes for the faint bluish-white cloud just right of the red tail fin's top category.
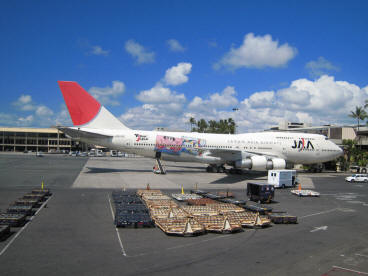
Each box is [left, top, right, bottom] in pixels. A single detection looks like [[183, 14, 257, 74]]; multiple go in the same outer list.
[[88, 80, 125, 106]]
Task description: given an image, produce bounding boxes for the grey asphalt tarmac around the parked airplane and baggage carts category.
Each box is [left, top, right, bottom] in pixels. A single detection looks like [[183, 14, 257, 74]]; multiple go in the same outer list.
[[0, 154, 368, 275]]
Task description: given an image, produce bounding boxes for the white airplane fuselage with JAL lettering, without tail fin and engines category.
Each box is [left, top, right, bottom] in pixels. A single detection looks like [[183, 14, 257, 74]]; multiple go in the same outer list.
[[71, 127, 342, 164]]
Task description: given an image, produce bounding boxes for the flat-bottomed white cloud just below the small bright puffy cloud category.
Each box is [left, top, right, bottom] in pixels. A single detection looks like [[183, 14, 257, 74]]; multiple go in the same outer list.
[[137, 83, 186, 104]]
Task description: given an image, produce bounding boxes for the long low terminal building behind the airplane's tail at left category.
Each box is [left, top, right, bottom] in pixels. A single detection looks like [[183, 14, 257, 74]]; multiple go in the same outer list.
[[0, 127, 84, 152]]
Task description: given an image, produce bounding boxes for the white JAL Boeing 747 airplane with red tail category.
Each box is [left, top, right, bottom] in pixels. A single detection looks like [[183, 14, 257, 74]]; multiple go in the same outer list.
[[58, 81, 342, 172]]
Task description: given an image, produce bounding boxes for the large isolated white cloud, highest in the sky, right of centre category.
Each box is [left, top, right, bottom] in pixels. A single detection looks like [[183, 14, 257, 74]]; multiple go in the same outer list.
[[214, 33, 297, 70]]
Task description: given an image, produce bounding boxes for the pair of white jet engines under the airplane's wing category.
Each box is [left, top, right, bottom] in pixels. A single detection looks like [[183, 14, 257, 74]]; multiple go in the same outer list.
[[235, 155, 286, 171]]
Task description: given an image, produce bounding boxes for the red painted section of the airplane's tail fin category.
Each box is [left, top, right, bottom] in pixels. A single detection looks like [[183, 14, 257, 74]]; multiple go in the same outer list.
[[58, 81, 101, 126]]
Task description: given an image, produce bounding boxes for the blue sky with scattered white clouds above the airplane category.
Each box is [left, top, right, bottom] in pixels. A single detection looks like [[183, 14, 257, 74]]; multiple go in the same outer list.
[[0, 1, 368, 132]]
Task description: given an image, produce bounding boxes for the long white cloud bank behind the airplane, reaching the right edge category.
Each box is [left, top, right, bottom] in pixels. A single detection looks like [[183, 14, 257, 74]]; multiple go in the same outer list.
[[120, 75, 368, 132]]
